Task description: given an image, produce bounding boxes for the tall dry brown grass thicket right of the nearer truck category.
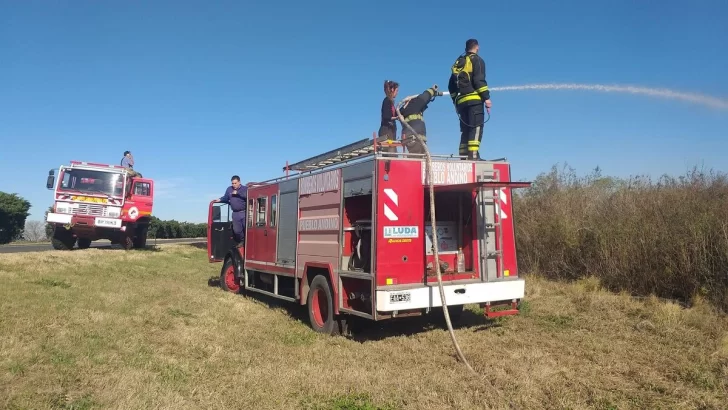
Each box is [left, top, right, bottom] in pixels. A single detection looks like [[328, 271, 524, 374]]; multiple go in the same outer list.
[[513, 165, 728, 311]]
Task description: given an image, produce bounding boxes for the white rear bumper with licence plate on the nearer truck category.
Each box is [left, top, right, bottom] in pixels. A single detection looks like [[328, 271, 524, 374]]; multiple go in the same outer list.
[[376, 279, 526, 312]]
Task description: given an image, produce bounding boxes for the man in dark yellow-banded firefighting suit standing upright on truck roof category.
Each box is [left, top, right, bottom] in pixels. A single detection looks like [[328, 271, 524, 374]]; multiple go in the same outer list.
[[448, 38, 491, 159]]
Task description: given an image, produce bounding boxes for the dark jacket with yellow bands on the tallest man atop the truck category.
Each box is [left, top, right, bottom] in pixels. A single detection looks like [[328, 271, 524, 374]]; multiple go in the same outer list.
[[447, 52, 490, 107]]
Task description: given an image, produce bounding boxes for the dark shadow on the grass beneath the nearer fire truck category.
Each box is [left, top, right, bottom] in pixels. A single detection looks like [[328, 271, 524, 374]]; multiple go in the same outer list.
[[207, 276, 502, 343]]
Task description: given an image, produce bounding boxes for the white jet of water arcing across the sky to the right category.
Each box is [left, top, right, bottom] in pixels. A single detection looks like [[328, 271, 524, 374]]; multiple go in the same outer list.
[[489, 84, 728, 110]]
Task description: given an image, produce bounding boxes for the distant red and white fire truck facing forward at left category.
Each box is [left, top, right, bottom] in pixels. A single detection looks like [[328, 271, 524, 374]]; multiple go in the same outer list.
[[46, 161, 154, 250]]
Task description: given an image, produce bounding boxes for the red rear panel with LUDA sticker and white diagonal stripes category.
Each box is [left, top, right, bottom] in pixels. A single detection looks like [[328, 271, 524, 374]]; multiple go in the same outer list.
[[376, 160, 425, 286]]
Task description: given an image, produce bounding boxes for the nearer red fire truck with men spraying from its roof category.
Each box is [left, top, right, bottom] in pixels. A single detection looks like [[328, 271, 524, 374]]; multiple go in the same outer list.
[[208, 138, 530, 334]]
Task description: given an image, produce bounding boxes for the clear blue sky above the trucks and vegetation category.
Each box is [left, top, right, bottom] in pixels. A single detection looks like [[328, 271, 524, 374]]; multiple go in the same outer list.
[[0, 0, 728, 222]]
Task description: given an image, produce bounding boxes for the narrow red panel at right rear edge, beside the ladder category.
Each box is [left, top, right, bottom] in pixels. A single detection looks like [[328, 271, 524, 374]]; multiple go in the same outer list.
[[493, 163, 518, 277]]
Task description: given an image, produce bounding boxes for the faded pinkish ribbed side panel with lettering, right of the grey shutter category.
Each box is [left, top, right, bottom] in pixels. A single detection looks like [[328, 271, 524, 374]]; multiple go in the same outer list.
[[296, 169, 341, 278]]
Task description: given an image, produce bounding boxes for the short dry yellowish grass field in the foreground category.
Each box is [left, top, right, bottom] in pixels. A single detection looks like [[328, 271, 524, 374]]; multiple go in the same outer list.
[[0, 245, 728, 409]]
